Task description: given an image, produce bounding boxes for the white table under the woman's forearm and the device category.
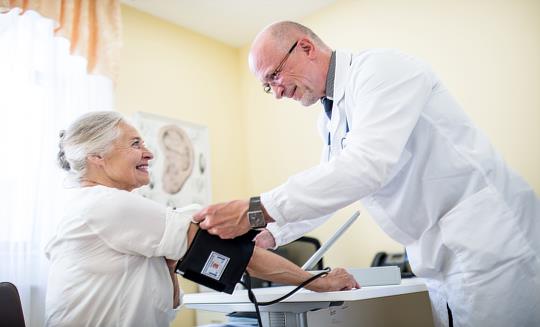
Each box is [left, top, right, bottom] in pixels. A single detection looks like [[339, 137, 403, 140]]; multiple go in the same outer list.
[[183, 278, 433, 327]]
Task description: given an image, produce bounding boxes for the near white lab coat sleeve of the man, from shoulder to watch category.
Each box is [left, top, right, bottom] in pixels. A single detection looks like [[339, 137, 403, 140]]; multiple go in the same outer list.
[[261, 52, 434, 226]]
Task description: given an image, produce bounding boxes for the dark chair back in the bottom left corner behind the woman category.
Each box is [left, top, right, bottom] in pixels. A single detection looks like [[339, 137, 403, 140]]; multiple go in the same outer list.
[[0, 282, 25, 327]]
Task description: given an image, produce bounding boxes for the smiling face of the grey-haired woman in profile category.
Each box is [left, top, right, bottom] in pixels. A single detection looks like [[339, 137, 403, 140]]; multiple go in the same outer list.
[[102, 123, 154, 191]]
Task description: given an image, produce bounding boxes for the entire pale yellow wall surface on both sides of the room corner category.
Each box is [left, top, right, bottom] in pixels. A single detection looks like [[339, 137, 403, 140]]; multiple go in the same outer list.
[[116, 0, 540, 326]]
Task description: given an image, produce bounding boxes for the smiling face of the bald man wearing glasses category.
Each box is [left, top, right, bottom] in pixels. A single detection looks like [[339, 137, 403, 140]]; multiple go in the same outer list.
[[249, 39, 326, 106]]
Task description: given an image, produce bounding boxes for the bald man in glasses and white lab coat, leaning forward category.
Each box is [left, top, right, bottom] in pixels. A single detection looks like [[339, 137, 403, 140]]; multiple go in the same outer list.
[[195, 22, 540, 326]]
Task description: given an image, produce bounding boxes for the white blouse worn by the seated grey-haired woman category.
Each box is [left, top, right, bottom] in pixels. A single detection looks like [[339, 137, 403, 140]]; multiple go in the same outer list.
[[45, 186, 199, 326]]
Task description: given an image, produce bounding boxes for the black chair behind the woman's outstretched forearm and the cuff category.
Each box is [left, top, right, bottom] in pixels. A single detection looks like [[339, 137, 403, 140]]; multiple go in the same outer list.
[[251, 236, 323, 288]]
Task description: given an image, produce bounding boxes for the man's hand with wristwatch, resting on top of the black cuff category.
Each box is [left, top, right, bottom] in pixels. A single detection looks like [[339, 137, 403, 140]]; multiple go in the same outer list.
[[193, 200, 250, 239]]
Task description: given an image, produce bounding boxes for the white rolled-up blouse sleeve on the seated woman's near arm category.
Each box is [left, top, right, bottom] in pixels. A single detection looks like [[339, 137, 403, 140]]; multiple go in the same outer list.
[[86, 190, 194, 260]]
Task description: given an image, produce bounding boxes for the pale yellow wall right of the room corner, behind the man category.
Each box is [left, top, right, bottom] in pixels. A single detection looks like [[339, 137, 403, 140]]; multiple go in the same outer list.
[[239, 0, 540, 267]]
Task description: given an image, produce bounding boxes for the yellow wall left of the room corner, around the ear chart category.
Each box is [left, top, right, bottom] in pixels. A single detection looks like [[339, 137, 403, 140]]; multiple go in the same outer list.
[[116, 6, 247, 327]]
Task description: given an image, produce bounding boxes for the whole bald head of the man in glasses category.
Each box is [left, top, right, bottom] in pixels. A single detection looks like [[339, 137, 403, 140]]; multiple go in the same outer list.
[[248, 21, 332, 106]]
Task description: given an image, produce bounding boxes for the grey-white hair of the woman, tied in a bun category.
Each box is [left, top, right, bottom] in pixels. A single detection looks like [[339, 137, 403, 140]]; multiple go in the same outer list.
[[58, 111, 126, 182]]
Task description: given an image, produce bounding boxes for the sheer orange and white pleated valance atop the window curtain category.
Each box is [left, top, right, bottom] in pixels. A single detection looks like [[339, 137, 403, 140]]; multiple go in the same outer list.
[[0, 0, 122, 81]]
